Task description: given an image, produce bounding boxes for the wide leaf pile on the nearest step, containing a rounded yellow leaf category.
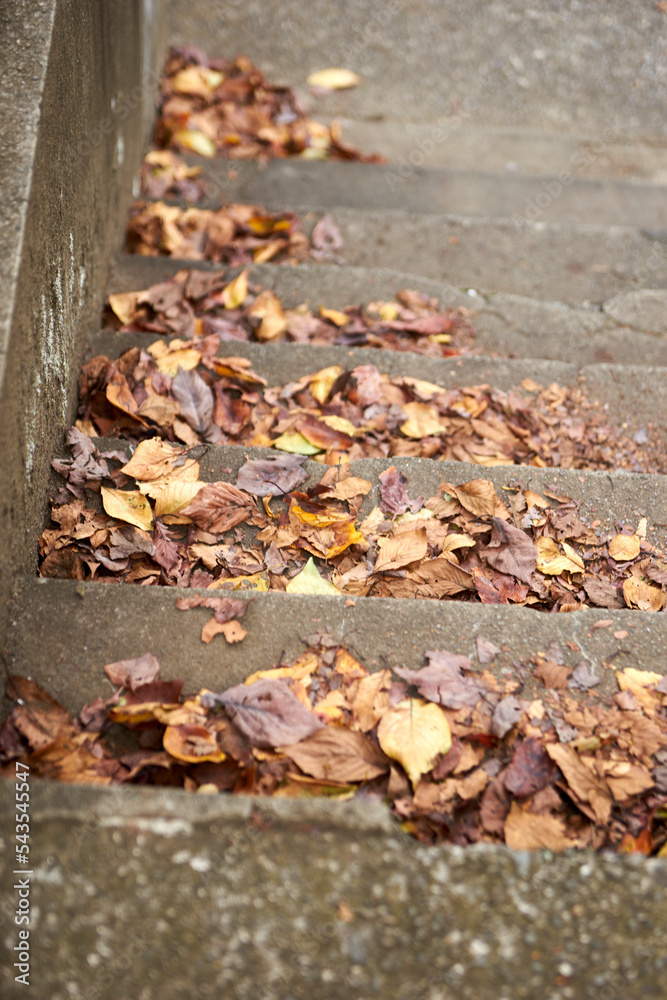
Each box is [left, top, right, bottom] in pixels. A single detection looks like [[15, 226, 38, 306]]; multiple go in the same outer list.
[[0, 640, 667, 857]]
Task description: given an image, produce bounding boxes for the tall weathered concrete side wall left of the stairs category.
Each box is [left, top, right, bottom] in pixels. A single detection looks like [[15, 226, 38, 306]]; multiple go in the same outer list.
[[0, 0, 164, 635]]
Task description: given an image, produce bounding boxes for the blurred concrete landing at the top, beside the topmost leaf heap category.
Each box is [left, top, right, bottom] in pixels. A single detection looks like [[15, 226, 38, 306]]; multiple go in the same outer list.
[[169, 0, 667, 151]]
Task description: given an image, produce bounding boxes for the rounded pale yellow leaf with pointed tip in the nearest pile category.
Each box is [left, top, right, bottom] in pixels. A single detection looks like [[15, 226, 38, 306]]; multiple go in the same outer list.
[[377, 698, 452, 788]]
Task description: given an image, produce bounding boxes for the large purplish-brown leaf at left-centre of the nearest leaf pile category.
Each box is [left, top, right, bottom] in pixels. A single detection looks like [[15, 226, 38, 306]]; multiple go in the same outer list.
[[201, 680, 323, 748]]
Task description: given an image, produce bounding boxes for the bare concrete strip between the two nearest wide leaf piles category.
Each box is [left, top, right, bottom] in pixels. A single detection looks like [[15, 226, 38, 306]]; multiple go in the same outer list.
[[2, 577, 667, 715]]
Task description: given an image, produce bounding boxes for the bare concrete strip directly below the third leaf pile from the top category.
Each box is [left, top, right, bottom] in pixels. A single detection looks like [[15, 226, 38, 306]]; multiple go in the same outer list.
[[88, 330, 667, 446]]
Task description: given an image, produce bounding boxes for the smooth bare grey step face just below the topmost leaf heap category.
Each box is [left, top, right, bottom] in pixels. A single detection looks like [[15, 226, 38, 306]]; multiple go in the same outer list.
[[180, 157, 667, 229]]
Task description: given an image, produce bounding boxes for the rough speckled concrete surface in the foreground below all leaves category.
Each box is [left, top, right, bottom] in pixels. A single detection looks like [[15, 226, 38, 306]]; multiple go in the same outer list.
[[0, 782, 667, 1000]]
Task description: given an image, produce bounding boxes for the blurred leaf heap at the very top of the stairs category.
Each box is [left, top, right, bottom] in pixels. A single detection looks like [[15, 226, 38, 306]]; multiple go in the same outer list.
[[150, 45, 384, 163]]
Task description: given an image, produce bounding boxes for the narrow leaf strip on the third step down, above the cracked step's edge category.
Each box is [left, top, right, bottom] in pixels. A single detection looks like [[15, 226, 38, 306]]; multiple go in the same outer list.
[[105, 270, 474, 357]]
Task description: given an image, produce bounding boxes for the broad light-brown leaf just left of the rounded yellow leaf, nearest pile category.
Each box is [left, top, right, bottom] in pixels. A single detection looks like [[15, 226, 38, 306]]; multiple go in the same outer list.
[[278, 726, 389, 781]]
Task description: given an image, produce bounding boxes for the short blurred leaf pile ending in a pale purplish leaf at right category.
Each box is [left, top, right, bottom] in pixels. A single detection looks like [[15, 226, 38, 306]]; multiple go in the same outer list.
[[127, 201, 342, 267]]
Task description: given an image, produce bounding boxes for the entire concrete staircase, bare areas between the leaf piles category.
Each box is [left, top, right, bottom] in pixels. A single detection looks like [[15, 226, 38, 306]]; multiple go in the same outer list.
[[0, 0, 667, 1000]]
